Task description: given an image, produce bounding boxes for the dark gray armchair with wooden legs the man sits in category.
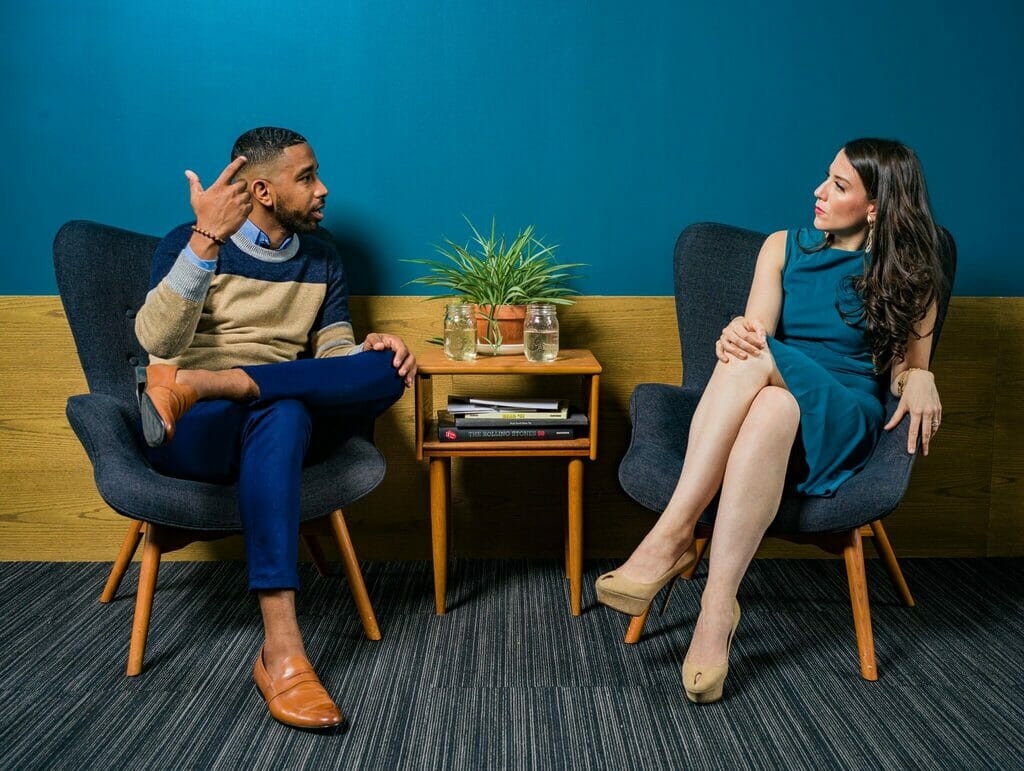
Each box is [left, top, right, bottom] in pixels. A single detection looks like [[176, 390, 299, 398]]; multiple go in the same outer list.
[[53, 221, 385, 676]]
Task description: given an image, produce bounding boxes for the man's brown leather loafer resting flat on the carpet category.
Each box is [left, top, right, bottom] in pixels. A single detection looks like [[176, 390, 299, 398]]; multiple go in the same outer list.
[[253, 648, 345, 728]]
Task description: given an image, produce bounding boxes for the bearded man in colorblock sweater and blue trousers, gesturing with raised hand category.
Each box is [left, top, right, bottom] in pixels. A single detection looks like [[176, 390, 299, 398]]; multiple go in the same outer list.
[[135, 128, 416, 728]]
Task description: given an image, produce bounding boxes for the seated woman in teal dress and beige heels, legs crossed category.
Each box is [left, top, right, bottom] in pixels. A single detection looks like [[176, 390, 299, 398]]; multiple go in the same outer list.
[[596, 139, 944, 702]]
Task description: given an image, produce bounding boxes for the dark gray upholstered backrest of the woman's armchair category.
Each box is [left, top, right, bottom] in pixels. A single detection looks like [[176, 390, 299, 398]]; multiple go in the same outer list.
[[675, 222, 956, 391]]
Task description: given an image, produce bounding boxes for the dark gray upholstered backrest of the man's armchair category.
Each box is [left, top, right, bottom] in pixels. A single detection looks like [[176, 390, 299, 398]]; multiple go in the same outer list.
[[53, 220, 160, 400]]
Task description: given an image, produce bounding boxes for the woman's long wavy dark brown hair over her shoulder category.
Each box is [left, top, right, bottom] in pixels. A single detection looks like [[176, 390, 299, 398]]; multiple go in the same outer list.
[[812, 139, 945, 373]]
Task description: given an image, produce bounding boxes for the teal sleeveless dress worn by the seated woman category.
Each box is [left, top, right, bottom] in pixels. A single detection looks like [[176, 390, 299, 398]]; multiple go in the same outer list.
[[768, 228, 886, 496]]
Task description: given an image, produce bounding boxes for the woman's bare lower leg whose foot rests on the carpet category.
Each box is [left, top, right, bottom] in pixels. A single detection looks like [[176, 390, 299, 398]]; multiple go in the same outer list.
[[686, 386, 800, 665]]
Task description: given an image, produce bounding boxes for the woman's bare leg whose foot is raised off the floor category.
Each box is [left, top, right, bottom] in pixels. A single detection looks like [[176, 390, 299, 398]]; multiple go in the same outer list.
[[618, 349, 784, 582]]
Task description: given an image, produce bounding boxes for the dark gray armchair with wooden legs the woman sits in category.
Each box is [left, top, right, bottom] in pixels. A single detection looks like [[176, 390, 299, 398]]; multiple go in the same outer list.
[[618, 223, 956, 680]]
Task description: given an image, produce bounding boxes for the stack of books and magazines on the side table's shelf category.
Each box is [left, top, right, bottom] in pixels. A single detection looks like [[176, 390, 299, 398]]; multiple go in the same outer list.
[[437, 396, 589, 441]]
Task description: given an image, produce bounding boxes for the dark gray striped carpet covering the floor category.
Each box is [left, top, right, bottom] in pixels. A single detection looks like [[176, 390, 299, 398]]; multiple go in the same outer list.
[[0, 560, 1024, 769]]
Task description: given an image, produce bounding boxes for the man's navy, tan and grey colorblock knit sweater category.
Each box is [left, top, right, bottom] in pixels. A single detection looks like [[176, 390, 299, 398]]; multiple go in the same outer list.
[[135, 224, 361, 370]]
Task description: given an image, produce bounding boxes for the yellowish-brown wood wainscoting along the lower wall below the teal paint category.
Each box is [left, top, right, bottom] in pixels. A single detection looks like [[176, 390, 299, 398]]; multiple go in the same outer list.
[[0, 296, 1024, 561]]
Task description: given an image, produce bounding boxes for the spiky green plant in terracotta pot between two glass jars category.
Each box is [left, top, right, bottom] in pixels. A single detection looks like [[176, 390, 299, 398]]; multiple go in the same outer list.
[[403, 215, 586, 353]]
